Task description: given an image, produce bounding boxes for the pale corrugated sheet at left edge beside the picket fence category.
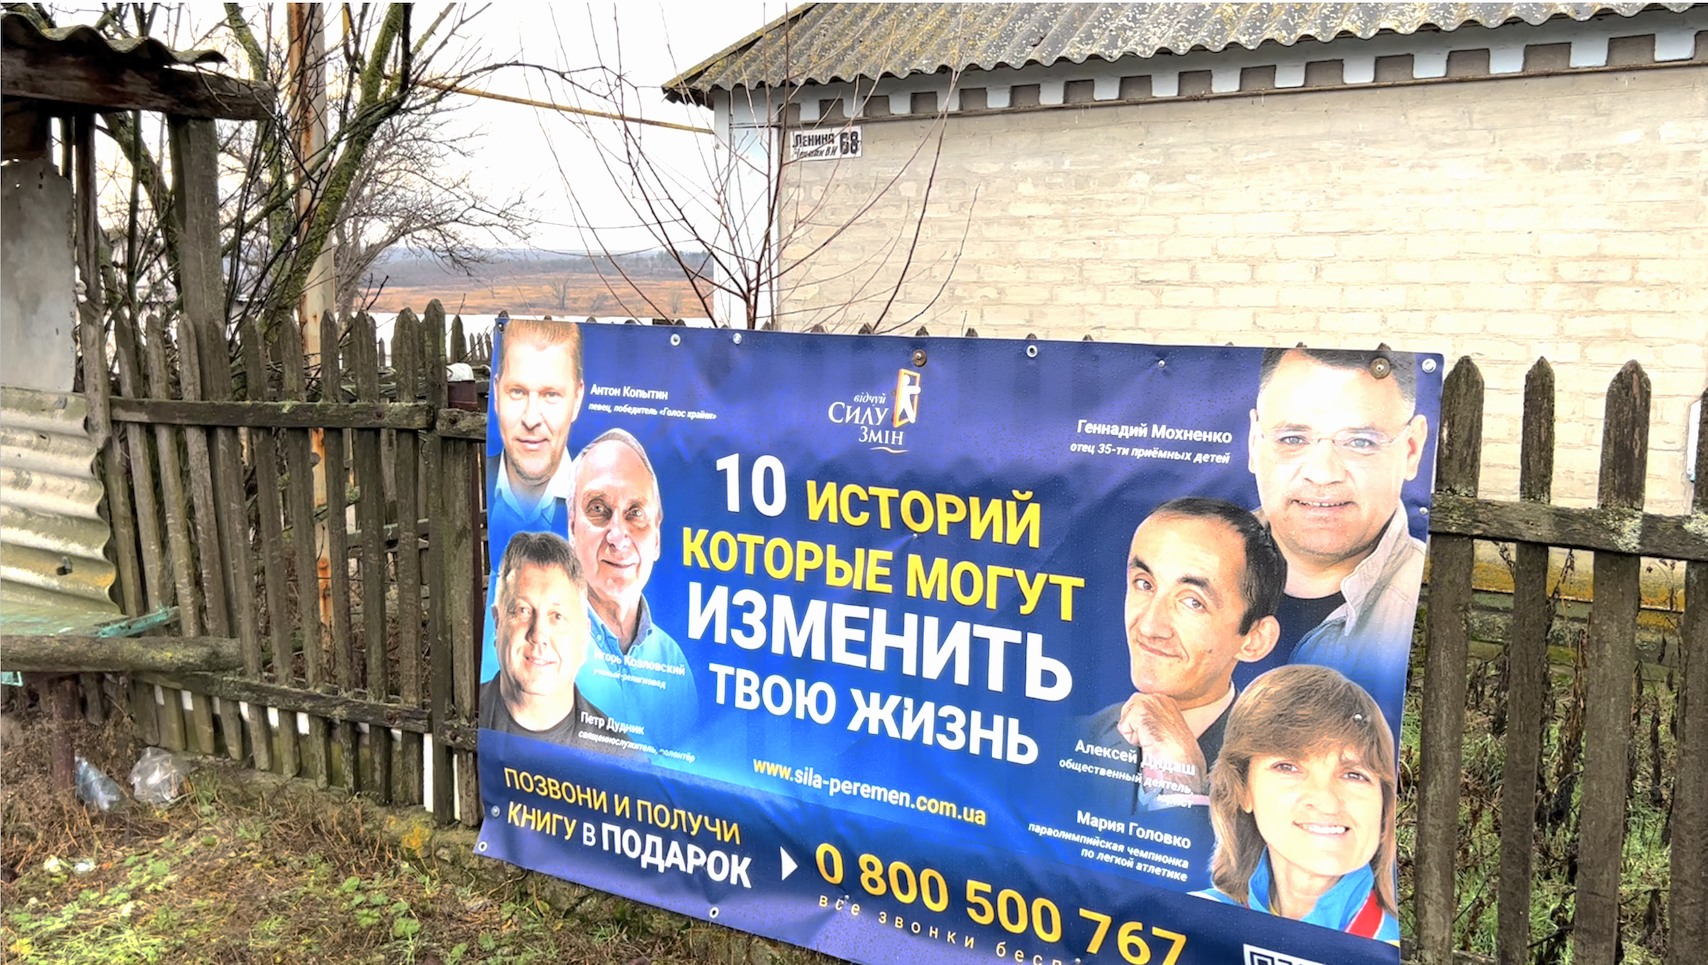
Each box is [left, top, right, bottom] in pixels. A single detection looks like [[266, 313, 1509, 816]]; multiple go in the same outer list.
[[0, 386, 123, 634]]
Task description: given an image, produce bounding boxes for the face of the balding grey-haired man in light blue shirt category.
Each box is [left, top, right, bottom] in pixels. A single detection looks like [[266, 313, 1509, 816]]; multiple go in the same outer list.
[[572, 441, 661, 610]]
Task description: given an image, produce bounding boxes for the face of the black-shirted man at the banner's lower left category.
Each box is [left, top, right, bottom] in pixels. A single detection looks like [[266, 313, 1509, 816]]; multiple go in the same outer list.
[[494, 564, 588, 712]]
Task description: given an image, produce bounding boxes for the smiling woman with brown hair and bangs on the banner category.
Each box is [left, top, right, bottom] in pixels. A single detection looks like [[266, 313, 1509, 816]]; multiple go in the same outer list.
[[1199, 664, 1399, 943]]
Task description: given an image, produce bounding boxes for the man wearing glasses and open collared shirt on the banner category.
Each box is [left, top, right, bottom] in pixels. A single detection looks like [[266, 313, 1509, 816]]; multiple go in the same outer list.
[[1240, 347, 1430, 733]]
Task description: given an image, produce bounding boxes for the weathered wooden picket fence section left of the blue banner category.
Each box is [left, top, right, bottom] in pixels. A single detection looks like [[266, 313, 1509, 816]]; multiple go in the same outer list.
[[91, 302, 485, 823]]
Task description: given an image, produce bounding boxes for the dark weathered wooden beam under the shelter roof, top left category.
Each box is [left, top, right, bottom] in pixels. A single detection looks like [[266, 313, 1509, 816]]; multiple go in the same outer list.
[[0, 48, 277, 121]]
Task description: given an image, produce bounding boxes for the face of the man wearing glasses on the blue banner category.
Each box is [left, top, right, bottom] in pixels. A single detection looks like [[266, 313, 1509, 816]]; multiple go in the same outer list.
[[1249, 352, 1428, 570]]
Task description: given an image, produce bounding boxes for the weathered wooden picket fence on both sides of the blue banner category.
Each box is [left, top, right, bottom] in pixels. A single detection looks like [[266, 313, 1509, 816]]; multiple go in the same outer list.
[[56, 302, 1708, 965]]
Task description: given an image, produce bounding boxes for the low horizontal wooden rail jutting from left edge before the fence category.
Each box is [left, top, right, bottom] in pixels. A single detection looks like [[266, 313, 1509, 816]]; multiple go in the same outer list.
[[0, 634, 243, 673]]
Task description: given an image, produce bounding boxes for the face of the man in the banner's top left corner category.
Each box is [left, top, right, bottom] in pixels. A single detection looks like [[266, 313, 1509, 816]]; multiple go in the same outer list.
[[492, 340, 581, 495]]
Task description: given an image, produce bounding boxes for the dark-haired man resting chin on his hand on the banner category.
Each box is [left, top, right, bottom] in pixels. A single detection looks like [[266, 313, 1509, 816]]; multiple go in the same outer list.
[[1076, 497, 1286, 813]]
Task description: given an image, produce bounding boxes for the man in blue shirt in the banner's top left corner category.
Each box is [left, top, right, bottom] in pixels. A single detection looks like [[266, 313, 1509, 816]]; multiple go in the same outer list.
[[487, 318, 584, 547]]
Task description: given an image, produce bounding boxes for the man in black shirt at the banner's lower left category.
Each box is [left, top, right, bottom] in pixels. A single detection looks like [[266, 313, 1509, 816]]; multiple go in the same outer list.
[[478, 531, 615, 750]]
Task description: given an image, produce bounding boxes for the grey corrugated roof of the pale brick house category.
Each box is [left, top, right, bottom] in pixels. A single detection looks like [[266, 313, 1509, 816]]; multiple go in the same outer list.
[[664, 2, 1691, 102]]
